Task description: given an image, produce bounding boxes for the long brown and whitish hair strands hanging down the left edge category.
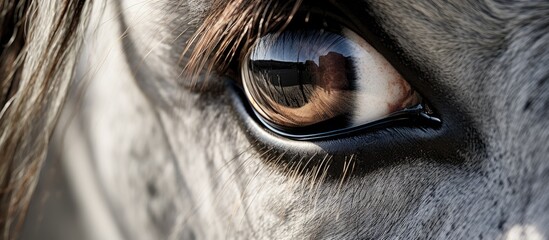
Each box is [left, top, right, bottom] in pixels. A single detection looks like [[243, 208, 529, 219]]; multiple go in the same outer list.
[[0, 0, 91, 239]]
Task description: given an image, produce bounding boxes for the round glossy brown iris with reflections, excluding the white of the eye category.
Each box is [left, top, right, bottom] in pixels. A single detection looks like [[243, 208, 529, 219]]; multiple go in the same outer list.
[[243, 30, 356, 127]]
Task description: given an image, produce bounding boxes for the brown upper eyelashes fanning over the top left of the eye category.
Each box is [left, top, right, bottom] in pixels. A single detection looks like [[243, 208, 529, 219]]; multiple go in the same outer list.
[[182, 0, 303, 88]]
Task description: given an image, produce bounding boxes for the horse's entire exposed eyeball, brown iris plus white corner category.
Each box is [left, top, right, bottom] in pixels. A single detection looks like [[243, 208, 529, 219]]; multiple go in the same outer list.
[[241, 28, 421, 136]]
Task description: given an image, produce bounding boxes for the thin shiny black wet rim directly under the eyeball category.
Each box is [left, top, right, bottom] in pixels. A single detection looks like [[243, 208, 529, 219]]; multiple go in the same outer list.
[[228, 81, 442, 141]]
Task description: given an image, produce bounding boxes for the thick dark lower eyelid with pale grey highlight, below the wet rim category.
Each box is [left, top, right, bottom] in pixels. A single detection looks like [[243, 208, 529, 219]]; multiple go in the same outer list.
[[227, 79, 463, 177]]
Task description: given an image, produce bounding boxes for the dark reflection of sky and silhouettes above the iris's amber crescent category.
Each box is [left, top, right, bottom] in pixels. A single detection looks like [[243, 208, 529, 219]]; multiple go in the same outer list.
[[248, 31, 354, 108]]
